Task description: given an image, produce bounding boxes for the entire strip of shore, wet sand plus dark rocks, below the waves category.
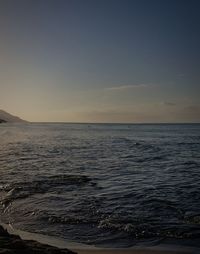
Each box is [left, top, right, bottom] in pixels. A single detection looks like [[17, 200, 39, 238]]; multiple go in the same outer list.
[[0, 223, 200, 254]]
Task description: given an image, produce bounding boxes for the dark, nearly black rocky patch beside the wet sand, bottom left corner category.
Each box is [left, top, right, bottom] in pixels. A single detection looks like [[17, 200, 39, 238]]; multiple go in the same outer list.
[[0, 226, 75, 254]]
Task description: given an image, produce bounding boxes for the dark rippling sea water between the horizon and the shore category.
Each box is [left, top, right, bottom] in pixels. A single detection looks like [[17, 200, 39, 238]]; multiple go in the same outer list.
[[0, 123, 200, 247]]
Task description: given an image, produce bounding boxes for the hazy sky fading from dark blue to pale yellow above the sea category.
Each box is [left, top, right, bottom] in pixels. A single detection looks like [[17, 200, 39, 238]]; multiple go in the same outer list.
[[0, 0, 200, 123]]
